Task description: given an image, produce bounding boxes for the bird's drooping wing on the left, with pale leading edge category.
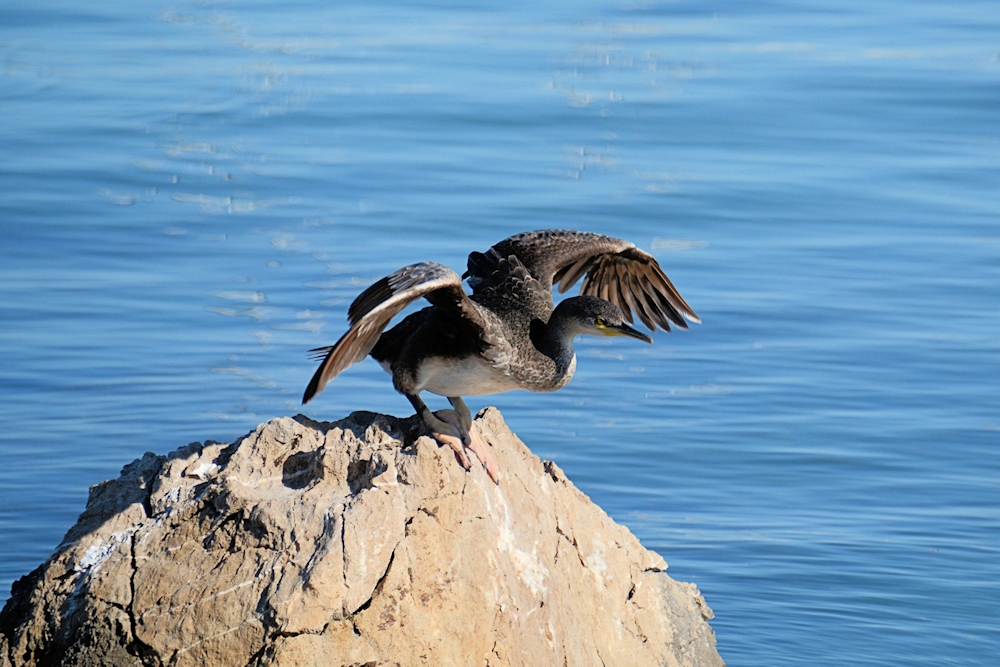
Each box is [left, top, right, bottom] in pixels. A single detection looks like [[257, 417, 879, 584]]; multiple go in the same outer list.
[[302, 262, 487, 403]]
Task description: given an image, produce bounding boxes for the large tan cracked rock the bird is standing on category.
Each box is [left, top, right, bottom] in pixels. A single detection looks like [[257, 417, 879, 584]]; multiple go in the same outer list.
[[0, 408, 723, 667]]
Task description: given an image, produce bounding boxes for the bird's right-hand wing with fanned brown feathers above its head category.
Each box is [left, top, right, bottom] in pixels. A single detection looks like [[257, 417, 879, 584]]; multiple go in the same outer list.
[[465, 230, 701, 331]]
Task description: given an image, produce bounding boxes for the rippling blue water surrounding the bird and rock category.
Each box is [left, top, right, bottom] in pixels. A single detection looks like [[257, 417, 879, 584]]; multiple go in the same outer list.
[[0, 0, 1000, 667]]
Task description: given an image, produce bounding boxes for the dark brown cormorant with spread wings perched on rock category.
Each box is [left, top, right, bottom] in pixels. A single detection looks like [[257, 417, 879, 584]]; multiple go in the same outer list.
[[302, 230, 701, 484]]
